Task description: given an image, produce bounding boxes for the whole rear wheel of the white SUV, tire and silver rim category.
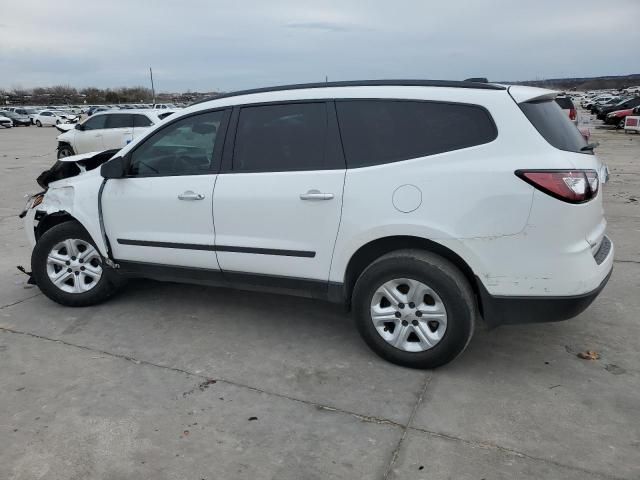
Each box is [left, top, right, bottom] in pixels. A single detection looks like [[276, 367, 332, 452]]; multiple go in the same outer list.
[[352, 250, 477, 369]]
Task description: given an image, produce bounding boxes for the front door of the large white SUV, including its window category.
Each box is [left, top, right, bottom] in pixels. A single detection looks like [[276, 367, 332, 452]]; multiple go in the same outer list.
[[102, 111, 226, 269]]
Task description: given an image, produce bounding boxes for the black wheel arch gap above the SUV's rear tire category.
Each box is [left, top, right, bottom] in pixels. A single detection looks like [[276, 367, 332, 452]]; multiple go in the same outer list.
[[344, 236, 482, 313]]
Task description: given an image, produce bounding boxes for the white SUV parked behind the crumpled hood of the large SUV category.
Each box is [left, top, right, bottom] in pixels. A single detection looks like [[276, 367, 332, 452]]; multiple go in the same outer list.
[[58, 110, 168, 158]]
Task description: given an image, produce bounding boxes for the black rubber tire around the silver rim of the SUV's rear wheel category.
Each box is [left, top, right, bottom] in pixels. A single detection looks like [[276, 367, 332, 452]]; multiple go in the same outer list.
[[353, 256, 475, 368]]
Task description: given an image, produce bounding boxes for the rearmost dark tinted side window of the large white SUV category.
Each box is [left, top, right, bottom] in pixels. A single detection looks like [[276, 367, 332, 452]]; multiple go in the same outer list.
[[336, 100, 498, 168]]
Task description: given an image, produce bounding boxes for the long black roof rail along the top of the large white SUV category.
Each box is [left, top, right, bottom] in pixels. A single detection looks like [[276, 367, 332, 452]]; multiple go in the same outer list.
[[191, 78, 506, 105]]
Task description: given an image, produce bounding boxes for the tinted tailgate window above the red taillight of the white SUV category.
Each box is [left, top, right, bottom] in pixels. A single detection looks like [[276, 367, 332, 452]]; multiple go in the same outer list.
[[520, 100, 592, 153]]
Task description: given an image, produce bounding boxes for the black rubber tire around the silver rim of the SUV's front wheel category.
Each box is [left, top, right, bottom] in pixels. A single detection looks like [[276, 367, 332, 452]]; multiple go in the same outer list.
[[31, 221, 116, 307]]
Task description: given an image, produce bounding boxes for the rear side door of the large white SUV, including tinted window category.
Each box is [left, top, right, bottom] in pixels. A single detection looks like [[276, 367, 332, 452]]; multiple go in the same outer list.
[[213, 101, 345, 281]]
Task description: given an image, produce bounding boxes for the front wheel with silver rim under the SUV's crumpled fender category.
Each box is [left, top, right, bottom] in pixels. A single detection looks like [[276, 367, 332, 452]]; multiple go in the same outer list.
[[31, 221, 121, 307]]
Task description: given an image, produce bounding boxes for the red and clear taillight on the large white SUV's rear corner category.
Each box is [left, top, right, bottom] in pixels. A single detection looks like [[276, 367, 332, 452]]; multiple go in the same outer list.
[[515, 170, 600, 203]]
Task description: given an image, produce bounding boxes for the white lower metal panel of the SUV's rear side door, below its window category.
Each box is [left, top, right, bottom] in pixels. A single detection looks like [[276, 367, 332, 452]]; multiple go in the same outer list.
[[213, 170, 345, 280]]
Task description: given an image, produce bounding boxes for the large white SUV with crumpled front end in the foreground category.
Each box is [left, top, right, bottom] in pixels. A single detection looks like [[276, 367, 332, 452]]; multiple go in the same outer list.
[[23, 81, 613, 368]]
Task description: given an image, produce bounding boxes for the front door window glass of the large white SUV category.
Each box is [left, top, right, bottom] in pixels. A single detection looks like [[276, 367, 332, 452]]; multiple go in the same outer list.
[[129, 111, 224, 177]]
